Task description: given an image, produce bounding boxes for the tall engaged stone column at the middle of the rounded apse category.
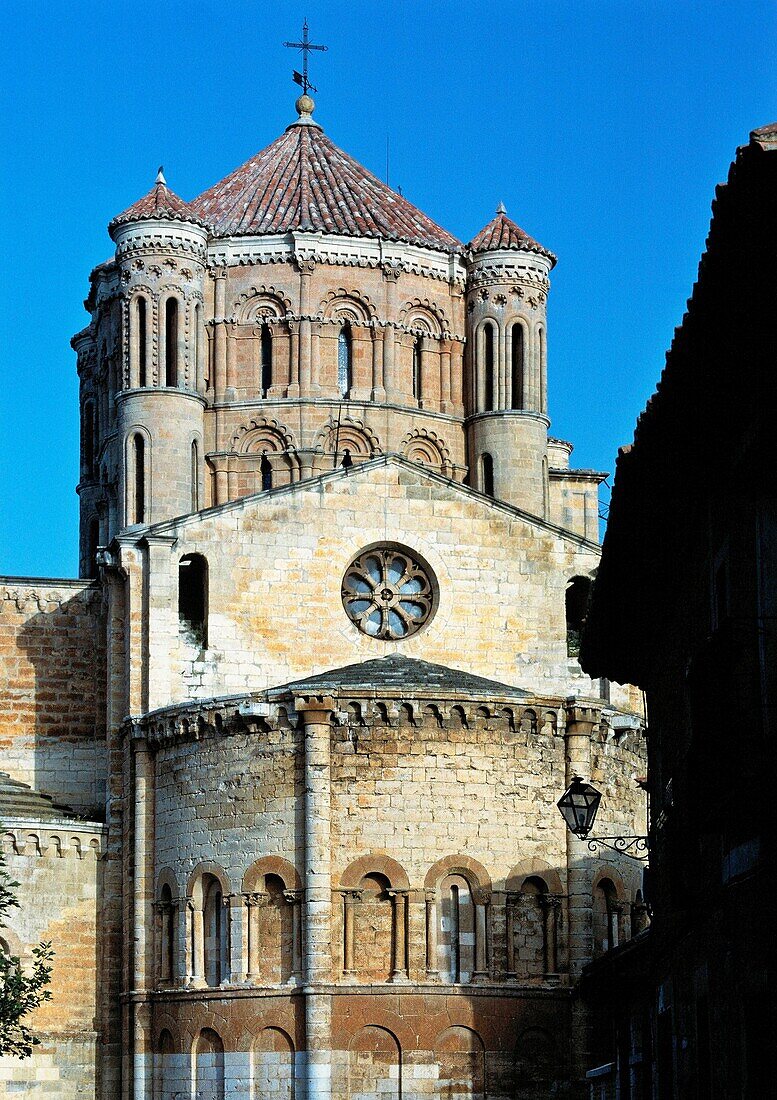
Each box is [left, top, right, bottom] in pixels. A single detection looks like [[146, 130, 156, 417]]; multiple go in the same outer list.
[[295, 700, 333, 1100]]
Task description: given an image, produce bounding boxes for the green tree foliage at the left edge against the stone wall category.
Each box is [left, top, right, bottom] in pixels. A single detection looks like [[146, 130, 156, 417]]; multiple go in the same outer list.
[[0, 855, 54, 1058]]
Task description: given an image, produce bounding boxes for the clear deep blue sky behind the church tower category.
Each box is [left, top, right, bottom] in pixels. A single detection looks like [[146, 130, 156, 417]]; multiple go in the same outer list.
[[0, 0, 777, 576]]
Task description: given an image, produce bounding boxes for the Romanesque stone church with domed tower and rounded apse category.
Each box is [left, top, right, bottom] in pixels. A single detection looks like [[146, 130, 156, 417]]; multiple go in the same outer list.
[[0, 81, 647, 1100]]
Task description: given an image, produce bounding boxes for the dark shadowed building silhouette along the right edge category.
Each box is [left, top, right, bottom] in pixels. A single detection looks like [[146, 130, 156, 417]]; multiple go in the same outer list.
[[581, 124, 777, 1100]]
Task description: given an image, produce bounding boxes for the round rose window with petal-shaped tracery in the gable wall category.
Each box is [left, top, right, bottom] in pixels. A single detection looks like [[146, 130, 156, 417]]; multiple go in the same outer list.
[[342, 547, 435, 641]]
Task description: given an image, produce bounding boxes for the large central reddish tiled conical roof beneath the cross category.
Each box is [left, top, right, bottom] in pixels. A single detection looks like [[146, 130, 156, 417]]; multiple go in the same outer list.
[[191, 116, 461, 251]]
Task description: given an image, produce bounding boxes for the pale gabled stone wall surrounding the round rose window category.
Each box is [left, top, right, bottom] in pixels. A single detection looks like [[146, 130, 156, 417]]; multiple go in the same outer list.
[[136, 460, 616, 708]]
